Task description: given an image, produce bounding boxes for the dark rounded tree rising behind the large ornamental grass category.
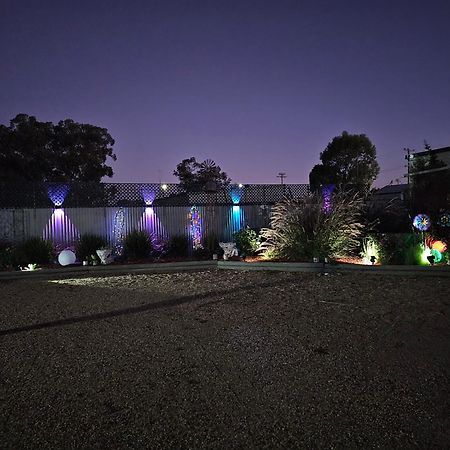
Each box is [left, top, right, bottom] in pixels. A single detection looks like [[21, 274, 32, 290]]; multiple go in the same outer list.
[[309, 131, 380, 192]]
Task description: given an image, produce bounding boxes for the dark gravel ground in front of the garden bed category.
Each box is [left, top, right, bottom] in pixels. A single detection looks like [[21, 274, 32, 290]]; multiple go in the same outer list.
[[0, 270, 450, 449]]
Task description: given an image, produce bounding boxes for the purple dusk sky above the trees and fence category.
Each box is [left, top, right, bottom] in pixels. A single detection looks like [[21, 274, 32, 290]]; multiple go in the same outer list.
[[0, 0, 450, 186]]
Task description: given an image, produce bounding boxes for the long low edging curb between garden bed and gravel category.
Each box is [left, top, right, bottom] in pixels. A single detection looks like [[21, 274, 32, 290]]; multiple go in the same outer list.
[[0, 260, 450, 281]]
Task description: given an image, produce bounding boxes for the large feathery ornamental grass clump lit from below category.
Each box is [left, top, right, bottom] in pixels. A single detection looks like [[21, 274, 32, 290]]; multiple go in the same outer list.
[[259, 193, 364, 260]]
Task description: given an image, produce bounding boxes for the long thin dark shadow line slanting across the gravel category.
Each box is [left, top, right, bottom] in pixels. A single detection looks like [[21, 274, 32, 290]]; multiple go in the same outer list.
[[0, 281, 294, 337]]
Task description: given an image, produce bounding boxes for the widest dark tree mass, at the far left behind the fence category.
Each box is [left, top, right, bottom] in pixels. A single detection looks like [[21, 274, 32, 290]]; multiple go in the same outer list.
[[0, 114, 117, 182]]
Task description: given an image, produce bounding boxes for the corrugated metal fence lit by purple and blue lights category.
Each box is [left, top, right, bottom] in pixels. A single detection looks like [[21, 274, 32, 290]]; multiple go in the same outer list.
[[0, 205, 271, 247]]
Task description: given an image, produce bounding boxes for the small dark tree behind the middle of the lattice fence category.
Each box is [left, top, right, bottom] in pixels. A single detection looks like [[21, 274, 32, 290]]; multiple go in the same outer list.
[[173, 157, 231, 191]]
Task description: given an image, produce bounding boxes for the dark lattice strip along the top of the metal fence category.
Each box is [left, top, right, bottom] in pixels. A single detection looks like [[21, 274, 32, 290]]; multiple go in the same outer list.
[[0, 182, 309, 208]]
